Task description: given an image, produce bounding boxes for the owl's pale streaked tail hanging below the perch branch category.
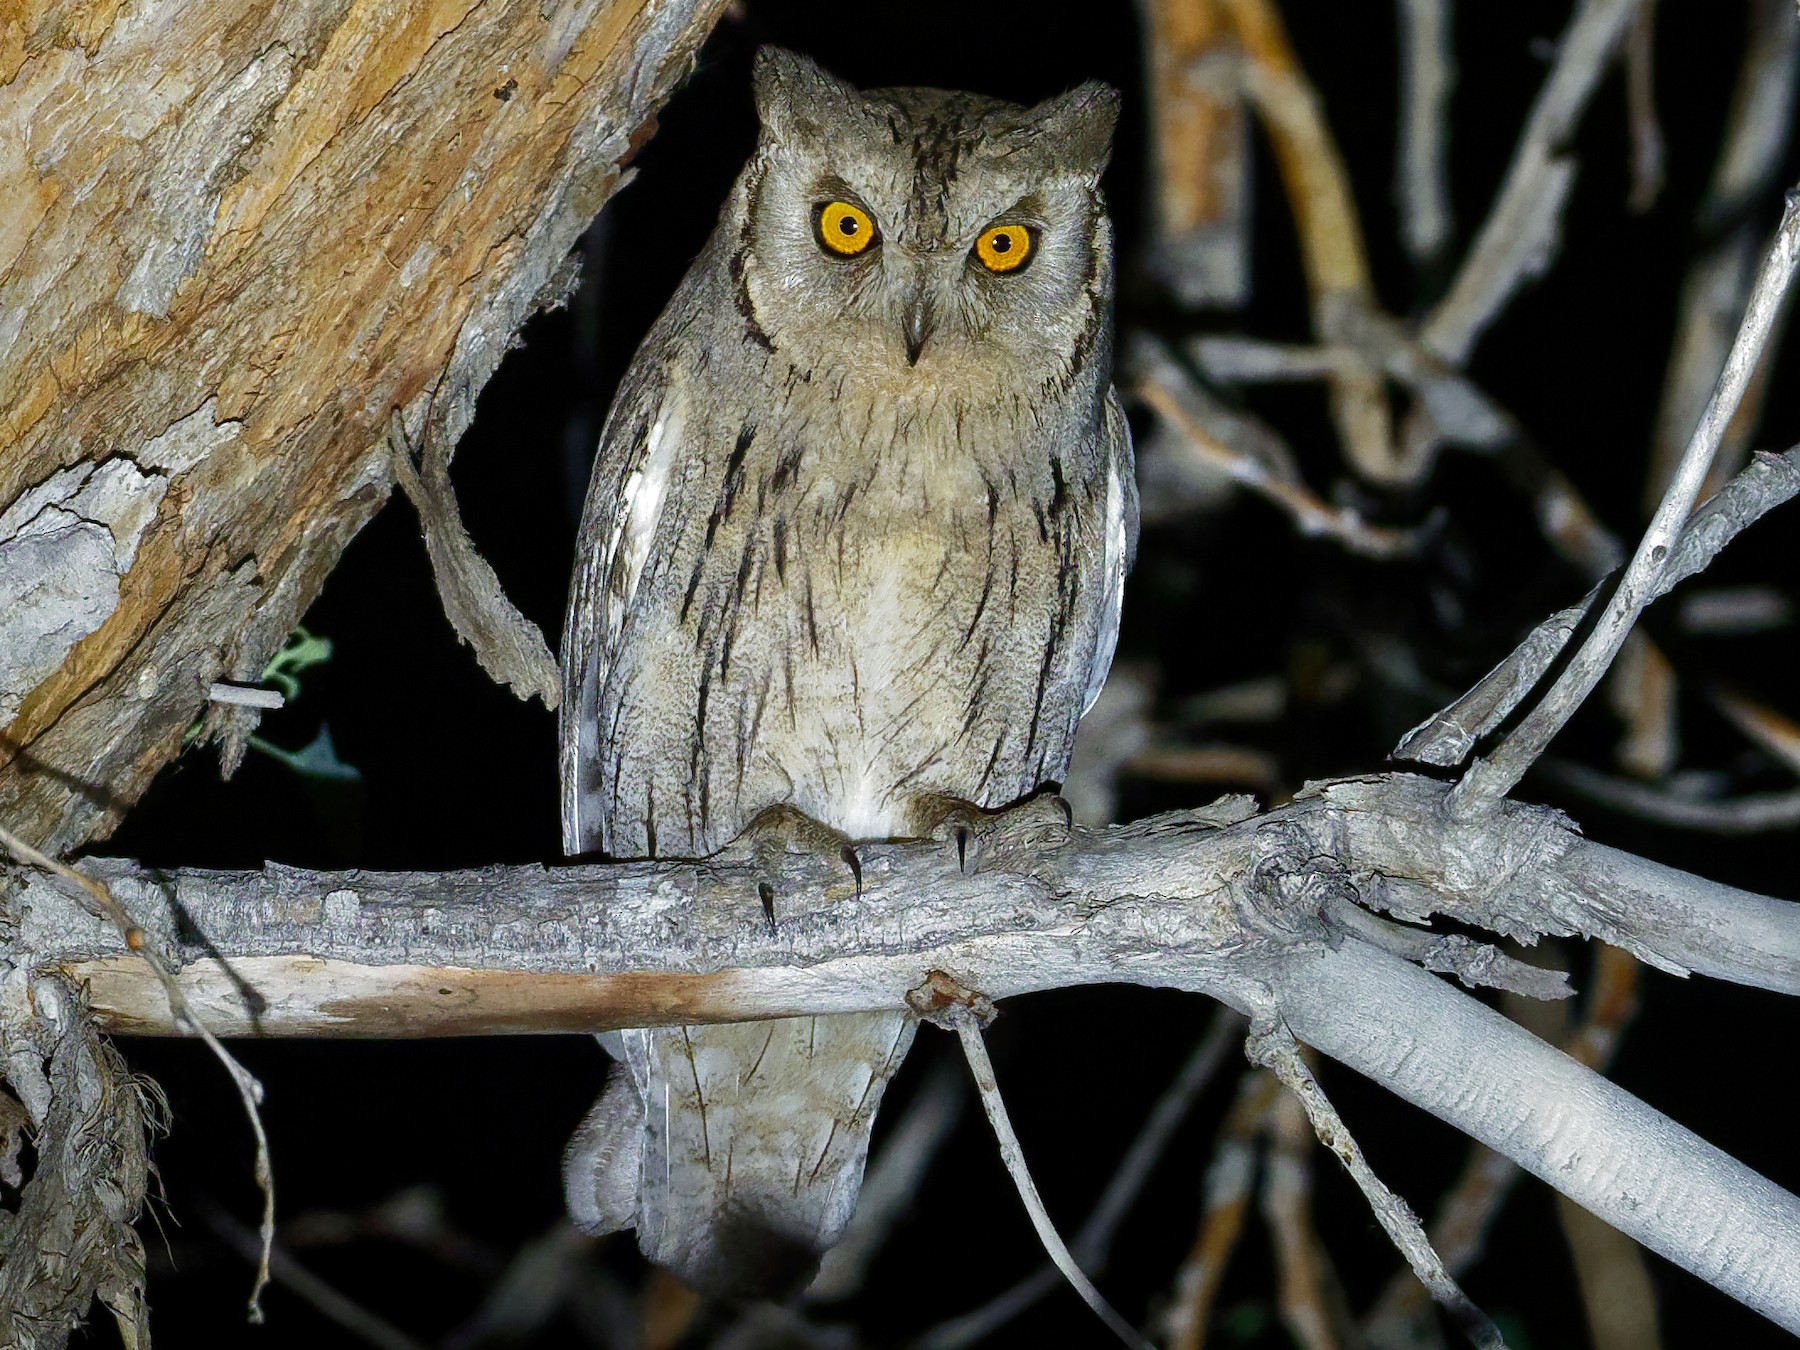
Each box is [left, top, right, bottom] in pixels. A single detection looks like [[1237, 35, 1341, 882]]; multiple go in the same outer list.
[[563, 1012, 918, 1296]]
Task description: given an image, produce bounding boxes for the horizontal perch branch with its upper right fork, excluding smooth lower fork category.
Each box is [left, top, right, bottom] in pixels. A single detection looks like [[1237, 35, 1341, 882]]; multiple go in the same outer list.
[[7, 774, 1800, 1037]]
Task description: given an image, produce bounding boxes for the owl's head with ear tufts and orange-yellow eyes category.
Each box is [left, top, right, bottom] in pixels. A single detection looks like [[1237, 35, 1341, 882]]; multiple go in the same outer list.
[[736, 47, 1118, 385]]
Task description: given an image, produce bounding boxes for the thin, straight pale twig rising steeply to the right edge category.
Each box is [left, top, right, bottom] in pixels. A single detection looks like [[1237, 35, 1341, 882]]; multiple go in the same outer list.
[[1456, 191, 1800, 812]]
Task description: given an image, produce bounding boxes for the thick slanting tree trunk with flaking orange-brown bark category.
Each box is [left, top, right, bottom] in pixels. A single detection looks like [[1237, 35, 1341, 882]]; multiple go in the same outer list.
[[0, 0, 724, 853]]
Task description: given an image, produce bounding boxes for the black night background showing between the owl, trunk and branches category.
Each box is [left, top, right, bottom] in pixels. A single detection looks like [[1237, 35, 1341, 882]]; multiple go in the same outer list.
[[102, 0, 1800, 1348]]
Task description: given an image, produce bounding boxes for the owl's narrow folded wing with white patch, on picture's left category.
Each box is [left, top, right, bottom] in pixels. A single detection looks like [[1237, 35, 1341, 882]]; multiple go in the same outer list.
[[558, 362, 686, 853]]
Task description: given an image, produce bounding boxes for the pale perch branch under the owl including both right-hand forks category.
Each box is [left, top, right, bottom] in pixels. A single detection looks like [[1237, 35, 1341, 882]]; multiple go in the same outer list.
[[10, 776, 1800, 1330]]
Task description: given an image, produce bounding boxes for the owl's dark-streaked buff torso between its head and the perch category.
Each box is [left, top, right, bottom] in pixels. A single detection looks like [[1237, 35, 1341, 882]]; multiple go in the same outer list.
[[571, 345, 1134, 855]]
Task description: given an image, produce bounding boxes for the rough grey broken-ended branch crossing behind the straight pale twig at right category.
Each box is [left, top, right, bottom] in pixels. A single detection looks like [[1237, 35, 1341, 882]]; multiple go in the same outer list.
[[1393, 446, 1800, 767]]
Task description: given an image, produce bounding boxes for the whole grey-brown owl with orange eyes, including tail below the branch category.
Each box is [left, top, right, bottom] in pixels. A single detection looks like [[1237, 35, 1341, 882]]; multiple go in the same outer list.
[[562, 49, 1138, 1292]]
